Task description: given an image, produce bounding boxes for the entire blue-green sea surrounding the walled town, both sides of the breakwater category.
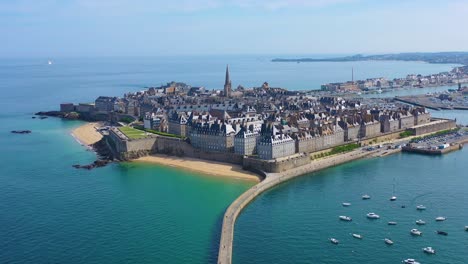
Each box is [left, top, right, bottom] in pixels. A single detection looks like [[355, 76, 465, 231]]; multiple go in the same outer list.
[[0, 55, 468, 264]]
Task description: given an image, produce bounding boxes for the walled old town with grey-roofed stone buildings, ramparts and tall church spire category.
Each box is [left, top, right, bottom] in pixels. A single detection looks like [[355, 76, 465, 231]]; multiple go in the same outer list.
[[53, 67, 455, 173]]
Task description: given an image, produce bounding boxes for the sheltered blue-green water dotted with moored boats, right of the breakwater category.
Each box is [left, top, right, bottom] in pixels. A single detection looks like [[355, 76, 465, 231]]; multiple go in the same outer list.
[[233, 151, 468, 264]]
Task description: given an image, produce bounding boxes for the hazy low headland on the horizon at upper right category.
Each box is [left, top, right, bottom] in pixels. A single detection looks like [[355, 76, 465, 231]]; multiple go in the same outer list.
[[271, 52, 468, 66]]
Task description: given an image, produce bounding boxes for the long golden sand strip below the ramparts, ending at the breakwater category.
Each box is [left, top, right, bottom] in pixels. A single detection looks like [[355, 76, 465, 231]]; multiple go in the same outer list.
[[135, 155, 260, 182]]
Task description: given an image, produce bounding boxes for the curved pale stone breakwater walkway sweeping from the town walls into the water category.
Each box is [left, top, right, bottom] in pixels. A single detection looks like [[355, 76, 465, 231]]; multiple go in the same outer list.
[[218, 149, 401, 264]]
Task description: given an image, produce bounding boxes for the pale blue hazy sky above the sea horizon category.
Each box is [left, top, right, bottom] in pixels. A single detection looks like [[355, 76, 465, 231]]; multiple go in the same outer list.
[[0, 0, 468, 57]]
